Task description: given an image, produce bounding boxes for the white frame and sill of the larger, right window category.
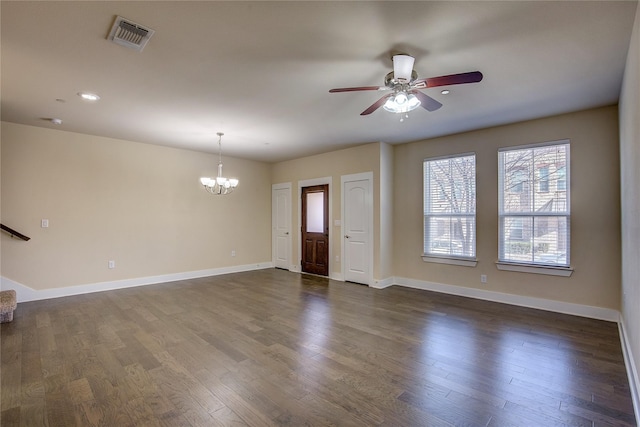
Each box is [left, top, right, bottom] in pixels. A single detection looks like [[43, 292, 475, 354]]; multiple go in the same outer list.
[[496, 140, 573, 276]]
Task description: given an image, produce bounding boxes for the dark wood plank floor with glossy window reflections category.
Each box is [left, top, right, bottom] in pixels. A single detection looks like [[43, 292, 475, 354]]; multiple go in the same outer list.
[[1, 270, 635, 427]]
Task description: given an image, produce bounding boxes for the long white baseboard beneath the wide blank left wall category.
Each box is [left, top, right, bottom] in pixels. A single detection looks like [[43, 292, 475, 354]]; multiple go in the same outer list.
[[0, 262, 273, 302]]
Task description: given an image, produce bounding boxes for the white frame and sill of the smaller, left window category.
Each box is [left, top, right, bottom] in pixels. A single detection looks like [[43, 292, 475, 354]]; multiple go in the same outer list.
[[422, 152, 477, 267]]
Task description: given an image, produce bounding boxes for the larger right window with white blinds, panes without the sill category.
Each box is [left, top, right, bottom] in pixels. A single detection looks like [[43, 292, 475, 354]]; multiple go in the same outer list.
[[498, 141, 570, 267]]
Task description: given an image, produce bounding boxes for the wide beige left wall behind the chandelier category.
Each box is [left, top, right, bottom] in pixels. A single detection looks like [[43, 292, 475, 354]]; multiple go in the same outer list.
[[1, 122, 271, 290]]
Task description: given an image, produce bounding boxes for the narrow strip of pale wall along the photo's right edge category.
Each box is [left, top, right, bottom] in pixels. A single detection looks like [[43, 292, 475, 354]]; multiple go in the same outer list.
[[620, 0, 640, 408]]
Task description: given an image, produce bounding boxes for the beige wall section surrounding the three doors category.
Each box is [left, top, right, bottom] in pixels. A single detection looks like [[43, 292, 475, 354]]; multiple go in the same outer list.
[[271, 143, 380, 278]]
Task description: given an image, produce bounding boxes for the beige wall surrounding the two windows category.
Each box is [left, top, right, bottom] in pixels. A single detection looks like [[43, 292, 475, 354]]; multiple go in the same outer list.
[[393, 106, 620, 310]]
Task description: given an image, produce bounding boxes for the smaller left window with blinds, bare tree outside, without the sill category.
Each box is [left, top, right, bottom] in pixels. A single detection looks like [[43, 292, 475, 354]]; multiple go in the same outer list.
[[423, 154, 476, 259]]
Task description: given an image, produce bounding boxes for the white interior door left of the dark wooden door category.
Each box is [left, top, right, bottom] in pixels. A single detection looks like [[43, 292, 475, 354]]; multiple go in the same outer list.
[[271, 184, 291, 270]]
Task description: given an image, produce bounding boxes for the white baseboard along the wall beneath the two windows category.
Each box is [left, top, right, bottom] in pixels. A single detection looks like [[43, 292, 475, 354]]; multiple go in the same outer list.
[[394, 277, 620, 322]]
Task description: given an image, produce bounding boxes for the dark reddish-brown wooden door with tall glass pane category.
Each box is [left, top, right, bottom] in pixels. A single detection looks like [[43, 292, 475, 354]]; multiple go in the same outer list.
[[301, 184, 329, 276]]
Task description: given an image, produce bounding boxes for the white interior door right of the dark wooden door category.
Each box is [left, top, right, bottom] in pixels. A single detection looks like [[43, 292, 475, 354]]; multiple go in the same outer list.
[[342, 177, 373, 285]]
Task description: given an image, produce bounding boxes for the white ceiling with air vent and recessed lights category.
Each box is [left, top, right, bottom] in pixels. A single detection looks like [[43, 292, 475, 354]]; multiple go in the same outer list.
[[0, 1, 638, 162]]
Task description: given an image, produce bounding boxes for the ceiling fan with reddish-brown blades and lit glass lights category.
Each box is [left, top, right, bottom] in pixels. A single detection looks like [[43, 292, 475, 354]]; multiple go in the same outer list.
[[329, 54, 482, 116]]
